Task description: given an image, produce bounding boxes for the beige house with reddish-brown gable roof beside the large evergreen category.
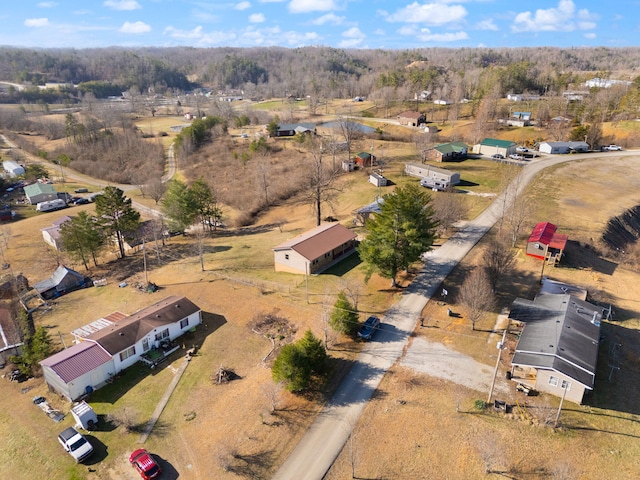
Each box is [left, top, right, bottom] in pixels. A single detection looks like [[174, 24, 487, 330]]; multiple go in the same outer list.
[[273, 223, 357, 274]]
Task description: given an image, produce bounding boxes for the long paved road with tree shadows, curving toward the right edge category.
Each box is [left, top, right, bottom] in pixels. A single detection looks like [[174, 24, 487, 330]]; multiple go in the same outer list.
[[273, 151, 638, 480]]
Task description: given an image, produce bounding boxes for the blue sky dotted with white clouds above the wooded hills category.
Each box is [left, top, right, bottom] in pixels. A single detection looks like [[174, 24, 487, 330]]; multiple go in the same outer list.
[[0, 0, 640, 49]]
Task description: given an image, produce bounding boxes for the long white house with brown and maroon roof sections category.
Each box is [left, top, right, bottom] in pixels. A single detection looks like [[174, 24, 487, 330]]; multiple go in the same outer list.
[[40, 296, 202, 400]]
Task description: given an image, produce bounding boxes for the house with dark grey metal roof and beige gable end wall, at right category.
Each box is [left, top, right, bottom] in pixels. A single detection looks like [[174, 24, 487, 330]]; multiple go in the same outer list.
[[509, 294, 603, 404]]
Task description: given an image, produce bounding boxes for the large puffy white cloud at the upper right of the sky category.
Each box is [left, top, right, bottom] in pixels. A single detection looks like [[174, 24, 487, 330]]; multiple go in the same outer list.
[[511, 0, 596, 32]]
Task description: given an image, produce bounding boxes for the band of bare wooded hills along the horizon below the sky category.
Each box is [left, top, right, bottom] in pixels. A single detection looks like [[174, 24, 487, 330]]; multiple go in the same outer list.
[[0, 47, 640, 102]]
